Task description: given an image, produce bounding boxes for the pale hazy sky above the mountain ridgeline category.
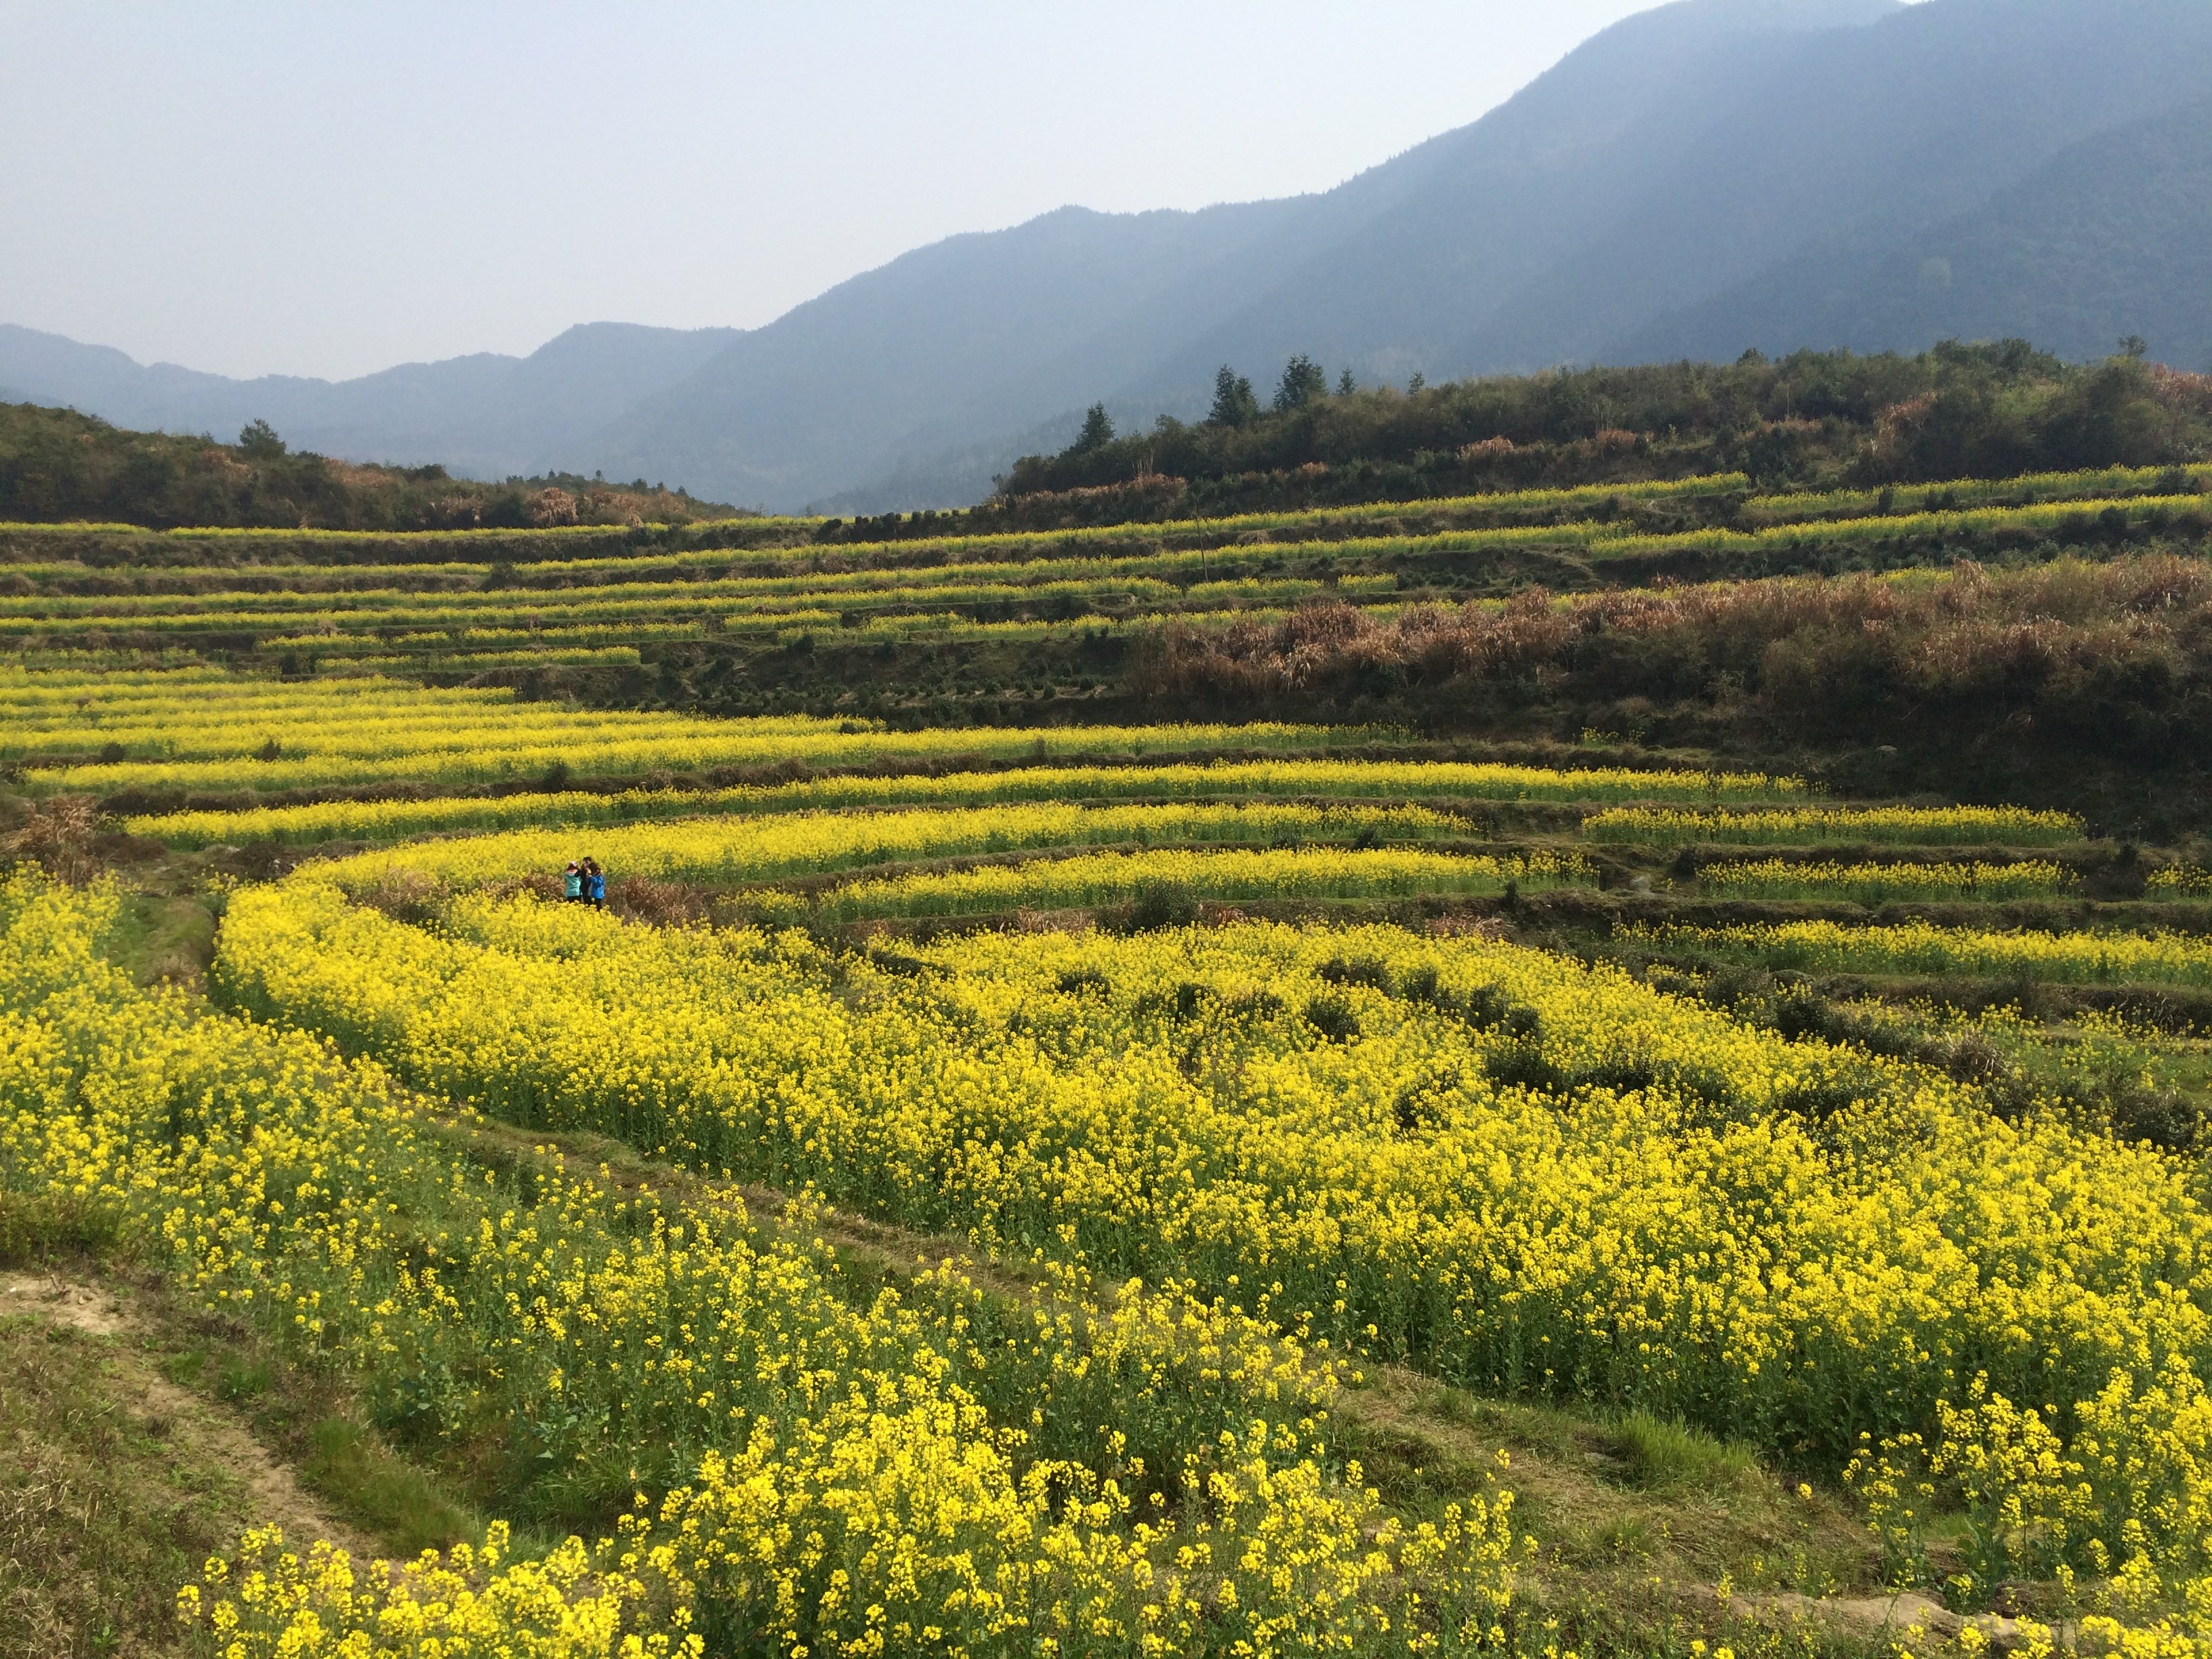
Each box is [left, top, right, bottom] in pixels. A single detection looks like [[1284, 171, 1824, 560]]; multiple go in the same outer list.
[[0, 0, 1645, 376]]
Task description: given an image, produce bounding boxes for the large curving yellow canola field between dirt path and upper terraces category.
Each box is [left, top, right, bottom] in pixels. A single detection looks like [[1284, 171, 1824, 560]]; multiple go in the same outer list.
[[172, 840, 2212, 1650]]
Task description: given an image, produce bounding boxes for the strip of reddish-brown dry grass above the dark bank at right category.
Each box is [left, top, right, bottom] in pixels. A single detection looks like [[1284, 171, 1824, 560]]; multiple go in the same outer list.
[[1143, 553, 2212, 747]]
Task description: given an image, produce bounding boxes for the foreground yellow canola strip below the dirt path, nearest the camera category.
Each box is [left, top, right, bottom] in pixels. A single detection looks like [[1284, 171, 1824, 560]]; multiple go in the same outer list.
[[0, 880, 1519, 1654]]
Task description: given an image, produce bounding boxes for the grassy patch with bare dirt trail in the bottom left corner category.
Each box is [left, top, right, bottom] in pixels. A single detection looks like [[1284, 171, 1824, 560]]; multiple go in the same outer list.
[[0, 1261, 483, 1659]]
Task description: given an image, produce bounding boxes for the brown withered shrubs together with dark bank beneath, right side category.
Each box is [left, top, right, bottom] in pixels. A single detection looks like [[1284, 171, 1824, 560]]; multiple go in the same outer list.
[[1139, 553, 2212, 763]]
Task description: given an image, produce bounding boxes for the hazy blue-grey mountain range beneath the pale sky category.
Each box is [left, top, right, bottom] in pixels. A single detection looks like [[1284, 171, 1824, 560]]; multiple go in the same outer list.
[[0, 0, 2212, 511]]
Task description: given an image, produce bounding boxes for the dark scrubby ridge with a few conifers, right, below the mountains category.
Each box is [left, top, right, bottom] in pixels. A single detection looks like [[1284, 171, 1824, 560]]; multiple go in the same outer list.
[[989, 341, 2212, 522]]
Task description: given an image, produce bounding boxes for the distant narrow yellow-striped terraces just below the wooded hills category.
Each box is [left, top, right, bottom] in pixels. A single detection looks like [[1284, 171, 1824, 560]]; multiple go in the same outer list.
[[0, 469, 2212, 694]]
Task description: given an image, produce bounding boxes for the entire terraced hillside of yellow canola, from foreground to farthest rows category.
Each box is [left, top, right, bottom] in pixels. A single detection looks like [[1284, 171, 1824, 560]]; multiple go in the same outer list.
[[13, 473, 2212, 1659]]
